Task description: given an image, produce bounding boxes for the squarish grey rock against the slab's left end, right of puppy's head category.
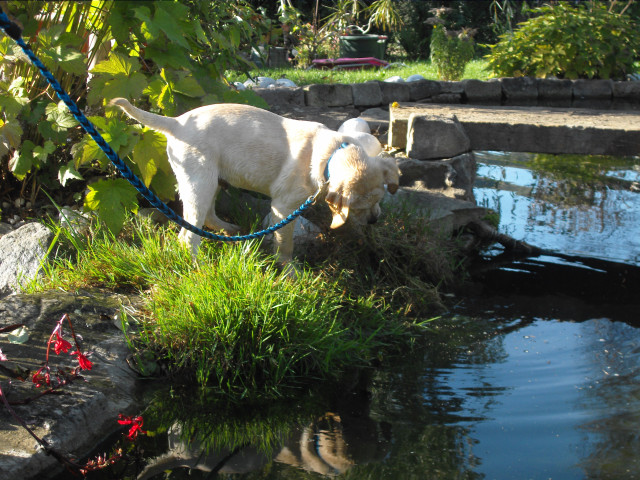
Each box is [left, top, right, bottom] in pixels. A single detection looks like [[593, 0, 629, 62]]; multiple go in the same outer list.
[[406, 114, 471, 160]]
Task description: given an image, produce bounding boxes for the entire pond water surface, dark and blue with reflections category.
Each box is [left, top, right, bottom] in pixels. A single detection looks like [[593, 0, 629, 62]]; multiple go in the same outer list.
[[77, 152, 640, 479]]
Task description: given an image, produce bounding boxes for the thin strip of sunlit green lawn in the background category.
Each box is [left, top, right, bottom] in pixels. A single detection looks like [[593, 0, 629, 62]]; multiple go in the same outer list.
[[227, 60, 489, 86]]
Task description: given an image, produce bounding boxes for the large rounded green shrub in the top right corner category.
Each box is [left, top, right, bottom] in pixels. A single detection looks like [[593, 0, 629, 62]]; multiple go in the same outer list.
[[486, 2, 640, 79]]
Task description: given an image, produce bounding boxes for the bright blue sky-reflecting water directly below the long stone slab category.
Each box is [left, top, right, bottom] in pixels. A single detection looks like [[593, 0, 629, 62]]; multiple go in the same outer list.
[[474, 152, 640, 265]]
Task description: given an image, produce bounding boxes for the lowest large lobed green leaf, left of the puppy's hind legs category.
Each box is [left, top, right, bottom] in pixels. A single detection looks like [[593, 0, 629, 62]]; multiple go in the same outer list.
[[84, 178, 138, 235]]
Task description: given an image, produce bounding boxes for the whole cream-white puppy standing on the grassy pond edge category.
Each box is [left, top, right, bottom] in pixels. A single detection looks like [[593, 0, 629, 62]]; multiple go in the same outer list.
[[111, 98, 400, 264]]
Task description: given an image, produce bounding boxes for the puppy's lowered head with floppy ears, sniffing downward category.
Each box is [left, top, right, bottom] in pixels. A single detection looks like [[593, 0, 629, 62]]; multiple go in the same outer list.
[[326, 144, 400, 228]]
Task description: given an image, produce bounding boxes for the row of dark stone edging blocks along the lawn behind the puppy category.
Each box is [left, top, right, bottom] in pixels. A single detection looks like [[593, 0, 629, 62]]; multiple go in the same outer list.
[[254, 77, 640, 110]]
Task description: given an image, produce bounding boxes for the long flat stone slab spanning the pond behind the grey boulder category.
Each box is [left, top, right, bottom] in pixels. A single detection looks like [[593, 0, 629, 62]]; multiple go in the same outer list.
[[389, 103, 640, 155]]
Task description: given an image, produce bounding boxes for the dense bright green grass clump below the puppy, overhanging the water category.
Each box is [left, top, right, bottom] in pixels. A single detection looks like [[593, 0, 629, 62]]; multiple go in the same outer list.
[[143, 243, 389, 398]]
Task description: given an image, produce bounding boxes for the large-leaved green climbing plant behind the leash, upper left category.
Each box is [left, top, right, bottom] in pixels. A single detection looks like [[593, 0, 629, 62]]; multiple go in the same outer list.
[[0, 0, 266, 232]]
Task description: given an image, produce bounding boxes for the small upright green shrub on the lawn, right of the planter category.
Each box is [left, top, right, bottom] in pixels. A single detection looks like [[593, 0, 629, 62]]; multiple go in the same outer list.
[[431, 25, 474, 80]]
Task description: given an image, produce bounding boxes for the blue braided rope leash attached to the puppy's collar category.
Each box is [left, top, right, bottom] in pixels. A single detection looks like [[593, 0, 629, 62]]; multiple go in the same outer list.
[[0, 10, 338, 242]]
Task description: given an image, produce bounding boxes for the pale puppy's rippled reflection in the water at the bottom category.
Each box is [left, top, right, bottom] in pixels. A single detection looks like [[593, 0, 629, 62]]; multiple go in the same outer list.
[[138, 412, 390, 480]]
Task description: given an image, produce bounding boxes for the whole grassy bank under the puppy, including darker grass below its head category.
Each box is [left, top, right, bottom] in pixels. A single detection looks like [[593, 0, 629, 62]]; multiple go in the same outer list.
[[32, 201, 454, 400]]
